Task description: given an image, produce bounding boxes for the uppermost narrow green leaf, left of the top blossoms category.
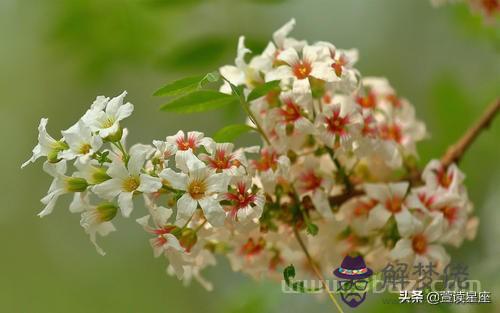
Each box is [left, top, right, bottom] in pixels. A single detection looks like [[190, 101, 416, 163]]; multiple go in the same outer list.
[[153, 72, 220, 97]]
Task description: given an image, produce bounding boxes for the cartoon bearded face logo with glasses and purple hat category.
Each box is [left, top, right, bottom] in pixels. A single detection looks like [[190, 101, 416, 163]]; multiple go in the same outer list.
[[333, 255, 373, 308]]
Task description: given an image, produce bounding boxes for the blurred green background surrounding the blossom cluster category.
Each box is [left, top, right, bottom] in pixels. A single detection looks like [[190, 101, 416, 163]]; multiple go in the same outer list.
[[0, 0, 500, 313]]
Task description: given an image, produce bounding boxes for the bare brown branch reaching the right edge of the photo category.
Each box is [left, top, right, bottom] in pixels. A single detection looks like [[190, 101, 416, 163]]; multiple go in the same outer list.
[[441, 98, 500, 167]]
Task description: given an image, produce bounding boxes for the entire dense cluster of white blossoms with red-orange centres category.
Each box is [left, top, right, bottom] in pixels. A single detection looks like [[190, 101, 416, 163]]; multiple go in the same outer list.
[[23, 20, 477, 288]]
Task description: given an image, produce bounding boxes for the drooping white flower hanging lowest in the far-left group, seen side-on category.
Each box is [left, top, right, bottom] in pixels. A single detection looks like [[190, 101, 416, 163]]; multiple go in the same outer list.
[[79, 196, 118, 255]]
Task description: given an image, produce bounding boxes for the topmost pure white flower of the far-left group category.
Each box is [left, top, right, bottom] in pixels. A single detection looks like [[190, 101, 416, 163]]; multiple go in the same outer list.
[[82, 91, 134, 138]]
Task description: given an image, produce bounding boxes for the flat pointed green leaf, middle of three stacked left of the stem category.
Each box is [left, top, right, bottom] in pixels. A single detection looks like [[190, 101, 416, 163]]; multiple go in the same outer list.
[[161, 90, 238, 113]]
